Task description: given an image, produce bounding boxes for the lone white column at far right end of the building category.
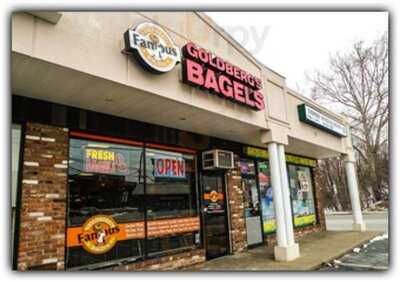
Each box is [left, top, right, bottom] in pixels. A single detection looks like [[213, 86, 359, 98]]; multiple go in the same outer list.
[[345, 157, 366, 231]]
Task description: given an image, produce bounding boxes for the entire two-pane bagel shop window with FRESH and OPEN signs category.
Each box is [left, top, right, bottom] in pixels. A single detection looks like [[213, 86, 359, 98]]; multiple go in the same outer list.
[[67, 139, 200, 268]]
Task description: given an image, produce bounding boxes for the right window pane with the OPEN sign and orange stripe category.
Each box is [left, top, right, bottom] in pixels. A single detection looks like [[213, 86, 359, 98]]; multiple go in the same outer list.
[[146, 149, 200, 254]]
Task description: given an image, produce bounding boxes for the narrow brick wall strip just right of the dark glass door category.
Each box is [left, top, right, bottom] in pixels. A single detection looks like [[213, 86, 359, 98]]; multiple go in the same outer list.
[[227, 156, 247, 253]]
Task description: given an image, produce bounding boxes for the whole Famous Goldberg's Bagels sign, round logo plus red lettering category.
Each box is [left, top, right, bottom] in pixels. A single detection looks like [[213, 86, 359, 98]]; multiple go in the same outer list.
[[124, 22, 265, 111]]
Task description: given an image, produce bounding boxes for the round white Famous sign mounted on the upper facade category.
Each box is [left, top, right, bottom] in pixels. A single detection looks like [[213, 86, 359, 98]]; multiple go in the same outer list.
[[124, 22, 181, 74]]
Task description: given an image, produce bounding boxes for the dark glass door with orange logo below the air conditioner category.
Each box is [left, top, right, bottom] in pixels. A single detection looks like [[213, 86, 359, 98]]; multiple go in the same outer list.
[[201, 172, 229, 259]]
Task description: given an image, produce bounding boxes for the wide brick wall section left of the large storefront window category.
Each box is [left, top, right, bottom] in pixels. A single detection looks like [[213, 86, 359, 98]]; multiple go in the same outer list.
[[18, 123, 68, 270]]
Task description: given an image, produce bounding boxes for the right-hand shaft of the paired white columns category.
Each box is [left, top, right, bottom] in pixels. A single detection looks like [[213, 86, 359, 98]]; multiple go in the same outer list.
[[278, 144, 294, 246]]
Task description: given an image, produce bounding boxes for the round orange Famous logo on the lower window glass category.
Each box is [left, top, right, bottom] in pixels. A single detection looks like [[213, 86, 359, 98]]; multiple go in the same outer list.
[[78, 215, 120, 255]]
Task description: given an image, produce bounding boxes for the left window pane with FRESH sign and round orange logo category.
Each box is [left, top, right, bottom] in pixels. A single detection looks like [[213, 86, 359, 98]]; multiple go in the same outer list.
[[67, 139, 144, 267]]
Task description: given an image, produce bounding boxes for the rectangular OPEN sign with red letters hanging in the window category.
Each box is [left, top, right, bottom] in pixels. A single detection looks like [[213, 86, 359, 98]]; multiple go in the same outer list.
[[154, 158, 186, 178]]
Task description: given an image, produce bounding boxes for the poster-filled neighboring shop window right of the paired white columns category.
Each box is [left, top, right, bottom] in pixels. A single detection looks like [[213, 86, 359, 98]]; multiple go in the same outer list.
[[288, 164, 316, 227]]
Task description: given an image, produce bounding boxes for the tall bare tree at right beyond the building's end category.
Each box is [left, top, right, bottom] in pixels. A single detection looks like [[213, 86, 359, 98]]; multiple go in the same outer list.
[[309, 32, 389, 209]]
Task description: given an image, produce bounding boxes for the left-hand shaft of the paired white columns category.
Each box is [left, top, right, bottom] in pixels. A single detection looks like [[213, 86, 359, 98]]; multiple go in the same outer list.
[[268, 143, 287, 248]]
